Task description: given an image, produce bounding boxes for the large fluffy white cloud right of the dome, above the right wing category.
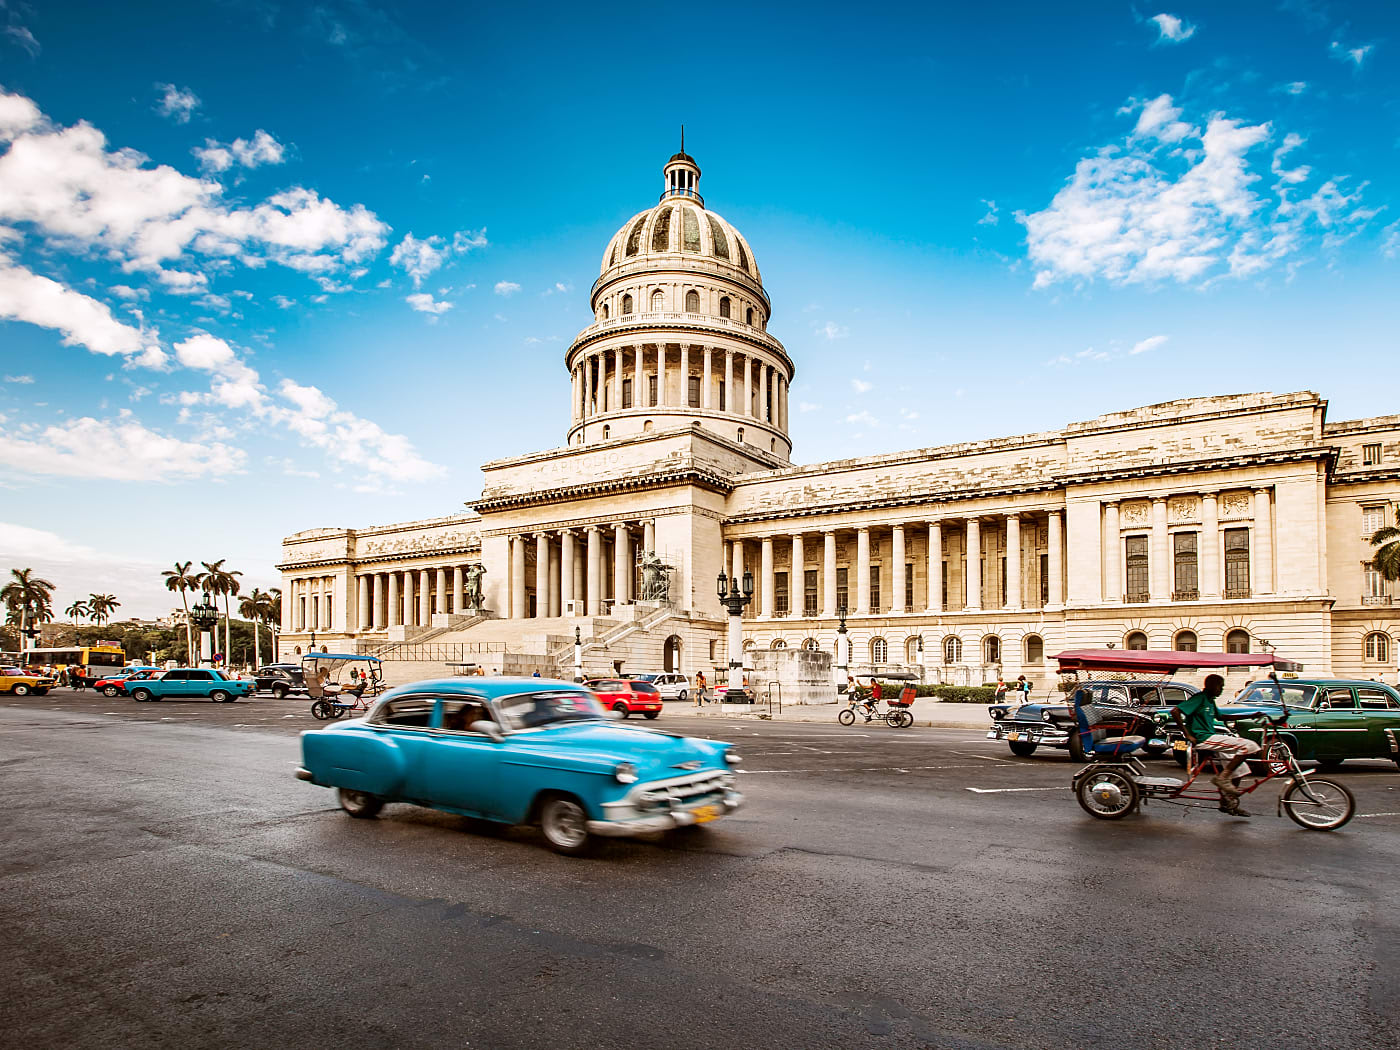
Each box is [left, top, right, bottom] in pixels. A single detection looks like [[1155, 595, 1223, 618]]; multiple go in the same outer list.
[[1016, 95, 1373, 288]]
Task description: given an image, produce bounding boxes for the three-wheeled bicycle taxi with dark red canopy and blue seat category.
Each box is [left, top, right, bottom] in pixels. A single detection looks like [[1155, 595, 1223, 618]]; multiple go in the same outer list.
[[1056, 650, 1357, 832]]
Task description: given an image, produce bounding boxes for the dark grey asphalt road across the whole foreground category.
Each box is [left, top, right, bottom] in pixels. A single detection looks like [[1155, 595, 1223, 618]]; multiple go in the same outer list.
[[8, 692, 1400, 1050]]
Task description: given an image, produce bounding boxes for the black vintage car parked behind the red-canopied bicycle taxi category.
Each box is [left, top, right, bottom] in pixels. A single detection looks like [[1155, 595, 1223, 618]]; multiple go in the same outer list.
[[987, 679, 1197, 762]]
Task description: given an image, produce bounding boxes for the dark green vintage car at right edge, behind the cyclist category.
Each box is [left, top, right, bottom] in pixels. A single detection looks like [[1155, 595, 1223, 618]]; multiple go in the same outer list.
[[1219, 678, 1400, 769]]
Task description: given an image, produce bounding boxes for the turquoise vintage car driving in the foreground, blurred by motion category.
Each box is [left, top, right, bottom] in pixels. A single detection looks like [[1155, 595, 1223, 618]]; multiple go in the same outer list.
[[297, 678, 743, 855]]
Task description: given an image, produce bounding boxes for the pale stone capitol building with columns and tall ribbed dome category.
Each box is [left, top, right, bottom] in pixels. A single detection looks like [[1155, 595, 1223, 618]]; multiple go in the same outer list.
[[279, 153, 1400, 687]]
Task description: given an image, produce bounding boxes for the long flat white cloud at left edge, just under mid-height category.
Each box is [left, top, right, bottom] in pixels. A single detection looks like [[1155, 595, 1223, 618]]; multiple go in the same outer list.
[[0, 410, 245, 482]]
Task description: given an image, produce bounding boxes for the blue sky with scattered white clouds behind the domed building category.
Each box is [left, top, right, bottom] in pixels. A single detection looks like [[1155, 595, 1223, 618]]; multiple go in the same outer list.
[[0, 0, 1400, 615]]
